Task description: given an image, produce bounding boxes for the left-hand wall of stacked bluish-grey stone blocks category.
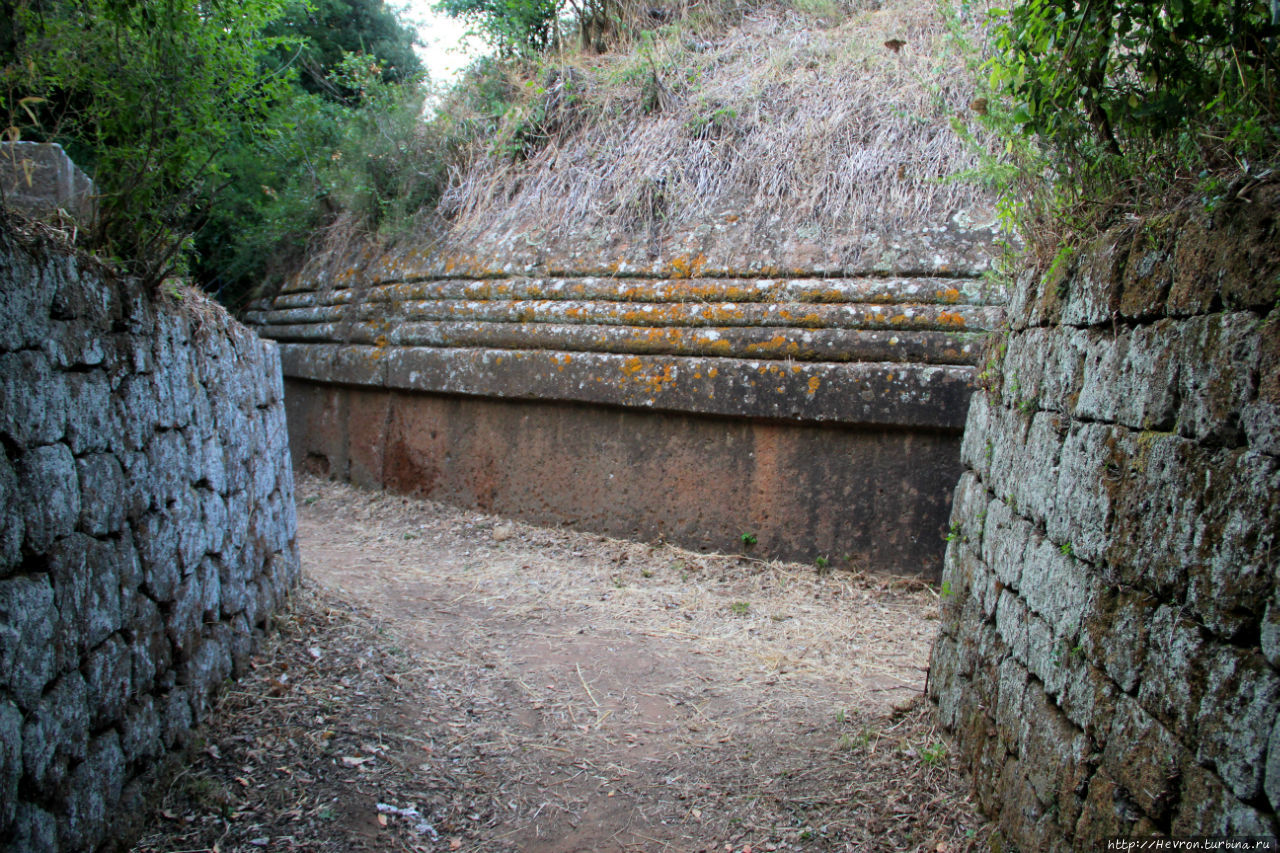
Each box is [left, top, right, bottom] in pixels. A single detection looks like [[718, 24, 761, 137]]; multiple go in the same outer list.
[[0, 220, 298, 852]]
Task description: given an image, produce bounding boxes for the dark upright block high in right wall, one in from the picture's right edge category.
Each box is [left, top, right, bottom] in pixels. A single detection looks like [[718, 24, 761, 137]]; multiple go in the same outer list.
[[1178, 313, 1260, 446]]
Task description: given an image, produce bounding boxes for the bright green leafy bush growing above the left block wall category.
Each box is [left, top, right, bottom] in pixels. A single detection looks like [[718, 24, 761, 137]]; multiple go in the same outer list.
[[0, 0, 288, 282]]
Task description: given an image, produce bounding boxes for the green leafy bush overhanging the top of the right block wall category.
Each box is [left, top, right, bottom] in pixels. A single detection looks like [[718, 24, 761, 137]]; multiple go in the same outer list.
[[974, 0, 1280, 229]]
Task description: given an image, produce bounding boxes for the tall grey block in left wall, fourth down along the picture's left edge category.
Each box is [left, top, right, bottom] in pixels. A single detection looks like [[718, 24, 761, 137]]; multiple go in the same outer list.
[[0, 575, 58, 711]]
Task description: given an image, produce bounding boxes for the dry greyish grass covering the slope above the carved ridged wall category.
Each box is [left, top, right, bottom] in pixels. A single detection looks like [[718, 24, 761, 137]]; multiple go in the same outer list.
[[424, 0, 989, 260]]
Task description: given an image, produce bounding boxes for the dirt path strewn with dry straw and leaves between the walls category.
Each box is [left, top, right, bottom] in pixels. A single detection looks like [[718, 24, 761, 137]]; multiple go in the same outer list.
[[136, 479, 984, 853]]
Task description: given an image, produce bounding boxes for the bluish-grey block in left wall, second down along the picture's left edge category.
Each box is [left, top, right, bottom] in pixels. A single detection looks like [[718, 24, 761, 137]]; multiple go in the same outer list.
[[0, 350, 70, 447]]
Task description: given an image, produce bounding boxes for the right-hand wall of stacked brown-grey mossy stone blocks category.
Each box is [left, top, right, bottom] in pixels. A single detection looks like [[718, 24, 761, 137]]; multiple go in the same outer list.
[[929, 187, 1280, 850]]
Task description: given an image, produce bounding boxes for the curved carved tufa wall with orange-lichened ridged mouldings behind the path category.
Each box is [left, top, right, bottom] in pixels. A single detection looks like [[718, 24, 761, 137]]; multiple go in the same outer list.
[[246, 253, 1002, 576]]
